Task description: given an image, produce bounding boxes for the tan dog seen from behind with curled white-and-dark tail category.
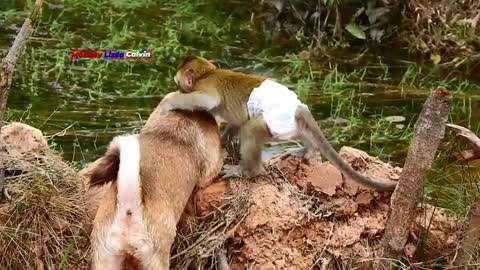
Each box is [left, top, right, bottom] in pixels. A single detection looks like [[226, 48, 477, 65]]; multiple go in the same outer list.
[[89, 93, 223, 270]]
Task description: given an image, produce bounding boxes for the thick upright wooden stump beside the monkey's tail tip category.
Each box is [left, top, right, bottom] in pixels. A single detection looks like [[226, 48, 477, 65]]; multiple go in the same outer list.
[[382, 88, 450, 259]]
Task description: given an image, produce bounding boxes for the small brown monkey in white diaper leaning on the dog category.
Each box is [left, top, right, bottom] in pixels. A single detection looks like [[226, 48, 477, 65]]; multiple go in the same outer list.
[[162, 56, 396, 190]]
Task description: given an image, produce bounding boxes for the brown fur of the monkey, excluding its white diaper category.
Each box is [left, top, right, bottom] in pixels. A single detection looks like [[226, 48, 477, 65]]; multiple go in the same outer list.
[[164, 56, 396, 190]]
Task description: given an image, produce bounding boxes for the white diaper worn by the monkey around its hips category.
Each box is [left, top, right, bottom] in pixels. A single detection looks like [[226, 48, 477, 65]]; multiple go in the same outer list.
[[247, 80, 306, 140]]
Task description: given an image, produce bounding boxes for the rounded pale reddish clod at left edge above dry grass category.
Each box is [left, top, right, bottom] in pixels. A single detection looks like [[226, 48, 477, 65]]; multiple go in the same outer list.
[[1, 122, 49, 156]]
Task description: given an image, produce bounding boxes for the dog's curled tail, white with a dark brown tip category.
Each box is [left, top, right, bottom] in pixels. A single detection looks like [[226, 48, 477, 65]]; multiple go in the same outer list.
[[89, 135, 140, 189]]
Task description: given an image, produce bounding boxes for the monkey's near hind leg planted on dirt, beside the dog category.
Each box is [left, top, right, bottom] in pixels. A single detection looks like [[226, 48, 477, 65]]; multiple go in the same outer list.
[[222, 115, 270, 178]]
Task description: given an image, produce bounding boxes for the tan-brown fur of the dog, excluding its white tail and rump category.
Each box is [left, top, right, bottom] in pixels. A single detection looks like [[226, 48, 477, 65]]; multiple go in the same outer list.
[[90, 92, 223, 269]]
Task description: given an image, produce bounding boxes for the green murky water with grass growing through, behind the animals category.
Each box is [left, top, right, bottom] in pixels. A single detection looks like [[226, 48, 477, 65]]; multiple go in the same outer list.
[[0, 0, 480, 171]]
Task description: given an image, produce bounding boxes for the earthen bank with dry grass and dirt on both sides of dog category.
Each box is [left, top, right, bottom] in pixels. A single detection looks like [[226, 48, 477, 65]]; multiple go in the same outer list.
[[0, 122, 463, 269]]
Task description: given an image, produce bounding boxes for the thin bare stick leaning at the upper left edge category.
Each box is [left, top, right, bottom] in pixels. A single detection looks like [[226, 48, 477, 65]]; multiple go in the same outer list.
[[0, 0, 43, 201]]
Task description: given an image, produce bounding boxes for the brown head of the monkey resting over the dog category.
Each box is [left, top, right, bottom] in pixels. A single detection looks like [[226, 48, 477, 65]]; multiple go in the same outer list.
[[173, 55, 220, 93]]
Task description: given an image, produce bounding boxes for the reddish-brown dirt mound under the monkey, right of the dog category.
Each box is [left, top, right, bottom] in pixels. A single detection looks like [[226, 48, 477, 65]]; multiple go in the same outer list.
[[172, 147, 460, 269]]
